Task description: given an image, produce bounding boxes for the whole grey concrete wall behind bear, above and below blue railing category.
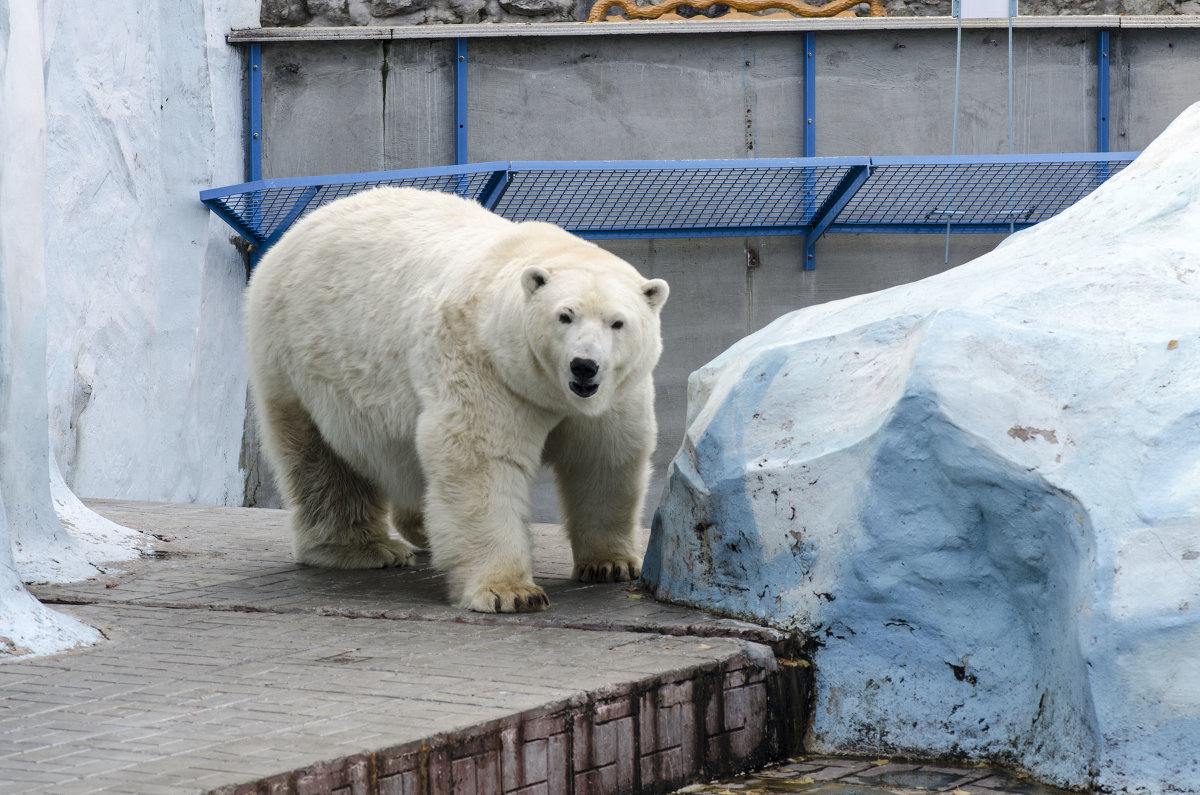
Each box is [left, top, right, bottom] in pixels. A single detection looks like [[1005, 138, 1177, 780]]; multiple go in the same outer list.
[[250, 28, 1200, 520]]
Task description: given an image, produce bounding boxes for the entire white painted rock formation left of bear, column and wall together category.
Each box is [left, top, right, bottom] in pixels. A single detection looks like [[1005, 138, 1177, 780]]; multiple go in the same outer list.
[[0, 0, 250, 663]]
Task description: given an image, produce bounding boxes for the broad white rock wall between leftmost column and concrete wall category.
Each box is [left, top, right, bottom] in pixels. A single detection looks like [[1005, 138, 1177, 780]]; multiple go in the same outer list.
[[42, 0, 258, 506]]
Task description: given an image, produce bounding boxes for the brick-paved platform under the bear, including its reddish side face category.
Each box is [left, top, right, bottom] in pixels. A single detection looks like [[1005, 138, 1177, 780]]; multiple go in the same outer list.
[[0, 501, 1084, 795]]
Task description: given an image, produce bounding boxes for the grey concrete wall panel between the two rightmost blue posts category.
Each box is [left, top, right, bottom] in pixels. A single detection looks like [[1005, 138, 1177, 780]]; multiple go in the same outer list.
[[816, 28, 1097, 155]]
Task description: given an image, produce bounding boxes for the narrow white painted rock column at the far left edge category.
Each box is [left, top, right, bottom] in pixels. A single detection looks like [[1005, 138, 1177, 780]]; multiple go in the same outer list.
[[0, 4, 117, 662]]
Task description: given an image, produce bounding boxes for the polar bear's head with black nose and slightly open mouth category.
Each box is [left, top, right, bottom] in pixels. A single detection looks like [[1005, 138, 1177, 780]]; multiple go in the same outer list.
[[521, 255, 668, 416]]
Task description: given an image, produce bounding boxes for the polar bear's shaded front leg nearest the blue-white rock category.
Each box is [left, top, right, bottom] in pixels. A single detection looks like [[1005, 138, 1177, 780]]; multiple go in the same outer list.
[[546, 393, 656, 582]]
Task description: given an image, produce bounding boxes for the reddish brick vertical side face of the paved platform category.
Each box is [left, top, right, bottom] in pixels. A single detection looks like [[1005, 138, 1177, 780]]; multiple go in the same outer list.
[[212, 656, 808, 795]]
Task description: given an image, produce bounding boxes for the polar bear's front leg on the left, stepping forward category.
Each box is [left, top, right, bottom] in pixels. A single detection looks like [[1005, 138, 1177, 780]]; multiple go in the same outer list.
[[416, 407, 550, 612]]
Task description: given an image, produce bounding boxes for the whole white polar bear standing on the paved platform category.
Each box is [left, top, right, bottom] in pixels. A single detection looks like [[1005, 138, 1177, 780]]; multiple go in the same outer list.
[[246, 187, 668, 612]]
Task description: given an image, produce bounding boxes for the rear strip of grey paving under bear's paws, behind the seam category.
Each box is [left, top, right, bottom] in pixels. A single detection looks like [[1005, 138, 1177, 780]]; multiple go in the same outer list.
[[35, 501, 785, 644]]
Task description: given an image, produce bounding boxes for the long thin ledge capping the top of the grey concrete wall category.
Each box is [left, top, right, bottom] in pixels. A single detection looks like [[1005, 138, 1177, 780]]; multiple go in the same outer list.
[[226, 16, 1200, 44]]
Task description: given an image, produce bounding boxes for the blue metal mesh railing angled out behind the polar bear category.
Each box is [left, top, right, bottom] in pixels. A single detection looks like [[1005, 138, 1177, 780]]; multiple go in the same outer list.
[[200, 153, 1136, 268]]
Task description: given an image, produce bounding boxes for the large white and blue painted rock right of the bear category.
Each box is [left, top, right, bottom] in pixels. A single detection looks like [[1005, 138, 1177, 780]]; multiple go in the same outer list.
[[643, 104, 1200, 793]]
